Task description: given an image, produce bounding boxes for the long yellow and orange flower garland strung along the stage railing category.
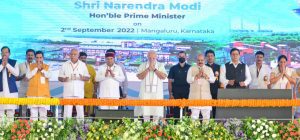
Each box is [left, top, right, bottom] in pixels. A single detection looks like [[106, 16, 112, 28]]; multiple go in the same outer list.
[[0, 98, 300, 107]]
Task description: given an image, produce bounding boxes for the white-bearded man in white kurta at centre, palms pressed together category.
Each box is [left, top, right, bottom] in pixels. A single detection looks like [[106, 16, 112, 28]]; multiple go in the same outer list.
[[134, 51, 167, 121]]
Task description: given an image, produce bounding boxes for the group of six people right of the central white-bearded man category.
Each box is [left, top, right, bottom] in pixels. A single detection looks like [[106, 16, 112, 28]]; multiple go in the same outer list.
[[168, 48, 296, 120]]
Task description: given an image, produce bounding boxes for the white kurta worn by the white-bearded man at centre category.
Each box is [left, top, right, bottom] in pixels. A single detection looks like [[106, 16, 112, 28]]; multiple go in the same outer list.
[[134, 62, 167, 117]]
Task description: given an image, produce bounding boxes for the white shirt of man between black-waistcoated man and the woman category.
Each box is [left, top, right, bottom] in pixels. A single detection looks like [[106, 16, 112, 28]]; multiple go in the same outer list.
[[249, 64, 271, 89]]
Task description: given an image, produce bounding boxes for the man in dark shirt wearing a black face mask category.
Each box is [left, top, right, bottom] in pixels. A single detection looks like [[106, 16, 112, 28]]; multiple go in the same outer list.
[[168, 51, 191, 118]]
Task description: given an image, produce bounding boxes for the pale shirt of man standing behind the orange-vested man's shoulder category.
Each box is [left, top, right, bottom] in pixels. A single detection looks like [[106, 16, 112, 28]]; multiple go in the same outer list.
[[19, 62, 29, 98]]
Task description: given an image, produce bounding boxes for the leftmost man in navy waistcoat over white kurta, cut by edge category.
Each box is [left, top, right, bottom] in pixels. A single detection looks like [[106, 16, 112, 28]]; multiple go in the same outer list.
[[0, 46, 19, 121]]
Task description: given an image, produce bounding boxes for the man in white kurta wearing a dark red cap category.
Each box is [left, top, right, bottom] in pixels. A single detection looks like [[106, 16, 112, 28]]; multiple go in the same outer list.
[[96, 53, 125, 110]]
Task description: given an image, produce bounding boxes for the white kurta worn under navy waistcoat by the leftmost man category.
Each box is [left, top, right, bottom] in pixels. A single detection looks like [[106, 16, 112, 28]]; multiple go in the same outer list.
[[0, 63, 19, 110]]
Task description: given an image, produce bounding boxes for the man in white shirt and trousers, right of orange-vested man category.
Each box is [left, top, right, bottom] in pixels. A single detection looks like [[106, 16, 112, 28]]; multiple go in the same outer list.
[[58, 49, 90, 119]]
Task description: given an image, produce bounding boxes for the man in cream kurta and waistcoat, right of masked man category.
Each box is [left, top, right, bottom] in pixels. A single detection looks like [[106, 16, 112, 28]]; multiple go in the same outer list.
[[187, 54, 216, 120]]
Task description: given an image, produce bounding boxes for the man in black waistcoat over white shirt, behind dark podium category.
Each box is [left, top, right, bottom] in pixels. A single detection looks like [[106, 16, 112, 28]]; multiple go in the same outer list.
[[220, 48, 251, 88]]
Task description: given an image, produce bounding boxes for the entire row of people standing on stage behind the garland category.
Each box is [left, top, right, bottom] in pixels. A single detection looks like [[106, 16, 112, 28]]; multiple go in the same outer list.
[[0, 46, 296, 121]]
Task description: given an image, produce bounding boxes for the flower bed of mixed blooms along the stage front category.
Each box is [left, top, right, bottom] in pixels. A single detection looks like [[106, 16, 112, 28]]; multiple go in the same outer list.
[[0, 118, 300, 140]]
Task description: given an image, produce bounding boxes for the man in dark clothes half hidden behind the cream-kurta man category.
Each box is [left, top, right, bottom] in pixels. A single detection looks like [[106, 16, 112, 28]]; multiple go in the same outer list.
[[205, 50, 220, 118]]
